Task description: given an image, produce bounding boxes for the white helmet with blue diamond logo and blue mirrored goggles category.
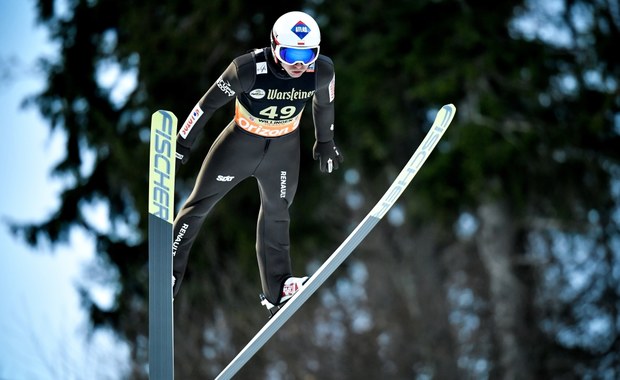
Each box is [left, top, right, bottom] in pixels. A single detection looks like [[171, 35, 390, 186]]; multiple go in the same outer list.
[[271, 11, 321, 65]]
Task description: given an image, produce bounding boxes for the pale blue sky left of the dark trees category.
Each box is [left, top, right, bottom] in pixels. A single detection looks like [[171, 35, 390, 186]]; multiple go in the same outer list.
[[0, 0, 127, 380]]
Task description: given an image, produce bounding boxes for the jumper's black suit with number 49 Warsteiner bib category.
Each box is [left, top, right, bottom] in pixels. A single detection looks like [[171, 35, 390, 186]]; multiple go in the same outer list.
[[172, 48, 335, 304]]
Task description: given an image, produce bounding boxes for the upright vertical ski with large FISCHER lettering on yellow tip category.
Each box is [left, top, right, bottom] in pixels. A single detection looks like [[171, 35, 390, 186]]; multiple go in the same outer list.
[[148, 111, 177, 380]]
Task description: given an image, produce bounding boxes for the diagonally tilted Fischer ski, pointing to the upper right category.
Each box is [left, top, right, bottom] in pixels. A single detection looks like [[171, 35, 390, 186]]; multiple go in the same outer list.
[[216, 104, 456, 380]]
